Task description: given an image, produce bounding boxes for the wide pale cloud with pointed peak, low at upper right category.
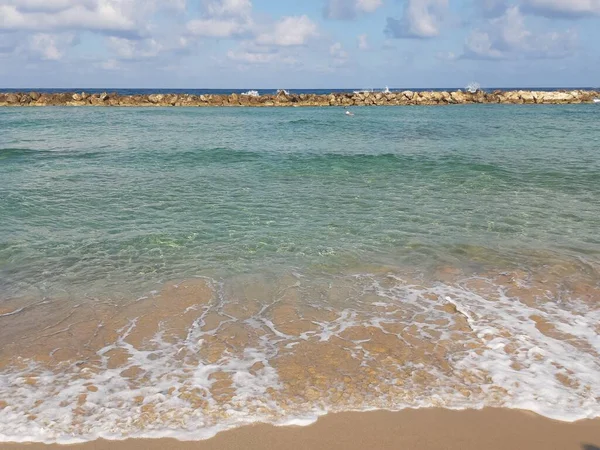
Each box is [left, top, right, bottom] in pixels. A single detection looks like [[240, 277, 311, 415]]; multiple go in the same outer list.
[[463, 6, 577, 59]]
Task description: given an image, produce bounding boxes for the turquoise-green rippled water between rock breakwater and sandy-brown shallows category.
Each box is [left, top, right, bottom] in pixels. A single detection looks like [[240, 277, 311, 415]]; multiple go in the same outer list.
[[0, 105, 600, 296]]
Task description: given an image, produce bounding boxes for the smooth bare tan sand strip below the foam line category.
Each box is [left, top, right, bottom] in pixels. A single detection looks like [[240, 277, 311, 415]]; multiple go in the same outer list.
[[0, 409, 600, 450]]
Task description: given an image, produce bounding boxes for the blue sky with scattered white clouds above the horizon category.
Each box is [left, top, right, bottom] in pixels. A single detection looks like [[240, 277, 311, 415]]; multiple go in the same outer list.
[[0, 0, 600, 89]]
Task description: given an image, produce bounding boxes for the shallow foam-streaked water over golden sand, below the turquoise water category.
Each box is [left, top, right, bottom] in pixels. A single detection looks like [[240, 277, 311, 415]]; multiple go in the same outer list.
[[0, 264, 600, 443]]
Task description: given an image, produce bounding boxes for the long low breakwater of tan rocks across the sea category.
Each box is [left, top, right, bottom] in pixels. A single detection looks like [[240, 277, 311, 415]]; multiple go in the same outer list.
[[0, 90, 600, 107]]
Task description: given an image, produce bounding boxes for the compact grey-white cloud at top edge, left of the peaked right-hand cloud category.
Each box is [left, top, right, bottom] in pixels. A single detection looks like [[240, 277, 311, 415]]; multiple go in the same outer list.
[[386, 0, 448, 39]]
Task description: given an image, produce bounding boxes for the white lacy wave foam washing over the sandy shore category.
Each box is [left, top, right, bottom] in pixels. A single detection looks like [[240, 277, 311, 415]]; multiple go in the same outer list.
[[0, 274, 600, 444]]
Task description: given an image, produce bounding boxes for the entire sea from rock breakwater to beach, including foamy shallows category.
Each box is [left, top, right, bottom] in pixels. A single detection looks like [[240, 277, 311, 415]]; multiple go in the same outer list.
[[0, 104, 600, 443]]
